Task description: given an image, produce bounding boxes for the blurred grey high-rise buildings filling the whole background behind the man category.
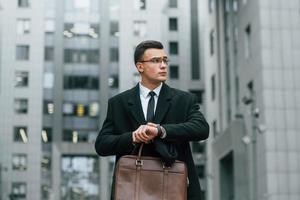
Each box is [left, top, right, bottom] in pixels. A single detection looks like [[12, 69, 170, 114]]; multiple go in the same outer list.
[[0, 0, 300, 200]]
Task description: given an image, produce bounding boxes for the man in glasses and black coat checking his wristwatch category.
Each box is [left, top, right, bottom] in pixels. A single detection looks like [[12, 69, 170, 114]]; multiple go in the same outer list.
[[95, 40, 209, 200]]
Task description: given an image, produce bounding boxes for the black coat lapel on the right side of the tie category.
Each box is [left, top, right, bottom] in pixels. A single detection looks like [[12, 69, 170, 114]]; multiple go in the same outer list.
[[154, 83, 172, 124]]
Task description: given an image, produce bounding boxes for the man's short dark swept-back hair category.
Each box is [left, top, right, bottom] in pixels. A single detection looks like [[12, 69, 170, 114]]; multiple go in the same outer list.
[[134, 40, 164, 64]]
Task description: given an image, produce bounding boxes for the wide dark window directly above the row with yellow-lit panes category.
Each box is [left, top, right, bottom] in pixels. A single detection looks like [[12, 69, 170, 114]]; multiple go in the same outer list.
[[64, 76, 99, 90]]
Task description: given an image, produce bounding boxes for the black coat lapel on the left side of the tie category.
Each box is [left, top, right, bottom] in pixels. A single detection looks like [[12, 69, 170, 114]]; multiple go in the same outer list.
[[128, 84, 146, 124]]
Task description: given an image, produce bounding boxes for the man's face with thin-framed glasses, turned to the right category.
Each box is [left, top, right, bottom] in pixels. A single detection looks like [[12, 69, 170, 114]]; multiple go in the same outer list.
[[136, 49, 168, 84]]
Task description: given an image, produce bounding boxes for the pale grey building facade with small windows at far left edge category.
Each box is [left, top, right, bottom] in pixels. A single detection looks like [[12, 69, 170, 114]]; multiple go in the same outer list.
[[0, 0, 44, 199]]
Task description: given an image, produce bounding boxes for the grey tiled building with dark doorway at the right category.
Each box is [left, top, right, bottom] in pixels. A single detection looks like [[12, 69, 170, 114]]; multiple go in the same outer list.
[[200, 0, 300, 200]]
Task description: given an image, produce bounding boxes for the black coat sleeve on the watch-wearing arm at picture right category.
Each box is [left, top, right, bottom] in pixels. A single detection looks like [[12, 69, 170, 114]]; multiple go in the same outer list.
[[162, 95, 209, 142]]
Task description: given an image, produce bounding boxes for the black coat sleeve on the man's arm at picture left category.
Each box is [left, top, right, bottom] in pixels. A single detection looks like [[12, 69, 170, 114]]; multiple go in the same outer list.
[[95, 100, 133, 156]]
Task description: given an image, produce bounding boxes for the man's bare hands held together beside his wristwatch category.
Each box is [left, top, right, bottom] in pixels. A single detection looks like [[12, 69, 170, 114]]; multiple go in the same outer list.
[[132, 123, 158, 143]]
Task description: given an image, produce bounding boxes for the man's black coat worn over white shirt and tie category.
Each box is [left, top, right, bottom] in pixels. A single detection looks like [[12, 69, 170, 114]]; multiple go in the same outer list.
[[95, 84, 209, 200]]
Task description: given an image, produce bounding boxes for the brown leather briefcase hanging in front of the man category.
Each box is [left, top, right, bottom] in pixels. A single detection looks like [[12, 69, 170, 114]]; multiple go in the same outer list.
[[114, 145, 188, 200]]
